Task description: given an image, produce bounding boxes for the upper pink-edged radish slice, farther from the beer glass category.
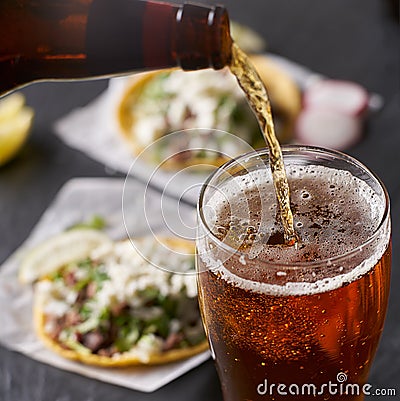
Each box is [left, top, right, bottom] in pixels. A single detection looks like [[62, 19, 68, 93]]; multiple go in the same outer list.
[[303, 80, 369, 116]]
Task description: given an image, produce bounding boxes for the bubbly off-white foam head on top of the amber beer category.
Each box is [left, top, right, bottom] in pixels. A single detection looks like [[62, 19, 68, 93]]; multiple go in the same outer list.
[[199, 165, 390, 295]]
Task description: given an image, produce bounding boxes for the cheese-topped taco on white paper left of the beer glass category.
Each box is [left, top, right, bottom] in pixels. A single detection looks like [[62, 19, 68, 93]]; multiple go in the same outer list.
[[29, 231, 208, 367]]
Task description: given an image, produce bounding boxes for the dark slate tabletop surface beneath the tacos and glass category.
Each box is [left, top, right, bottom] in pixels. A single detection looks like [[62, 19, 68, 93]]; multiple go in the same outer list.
[[0, 0, 400, 401]]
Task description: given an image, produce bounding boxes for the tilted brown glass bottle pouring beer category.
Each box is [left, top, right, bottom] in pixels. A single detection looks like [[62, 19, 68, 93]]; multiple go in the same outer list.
[[0, 0, 232, 95]]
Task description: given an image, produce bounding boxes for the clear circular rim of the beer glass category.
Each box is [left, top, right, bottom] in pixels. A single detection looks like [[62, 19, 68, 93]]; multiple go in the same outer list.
[[196, 145, 391, 270]]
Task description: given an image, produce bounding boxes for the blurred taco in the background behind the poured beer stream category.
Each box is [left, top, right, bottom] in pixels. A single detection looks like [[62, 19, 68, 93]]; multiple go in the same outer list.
[[116, 56, 301, 168]]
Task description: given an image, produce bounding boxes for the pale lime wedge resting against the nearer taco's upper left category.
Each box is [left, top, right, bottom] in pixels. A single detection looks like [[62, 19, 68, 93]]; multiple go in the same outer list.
[[19, 229, 111, 284]]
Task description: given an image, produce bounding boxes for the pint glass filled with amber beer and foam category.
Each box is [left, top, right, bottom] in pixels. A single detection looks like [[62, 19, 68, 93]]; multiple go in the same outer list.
[[196, 146, 391, 401]]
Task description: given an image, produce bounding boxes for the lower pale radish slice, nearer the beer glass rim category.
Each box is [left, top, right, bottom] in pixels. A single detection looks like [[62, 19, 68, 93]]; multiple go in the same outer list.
[[295, 107, 362, 150]]
